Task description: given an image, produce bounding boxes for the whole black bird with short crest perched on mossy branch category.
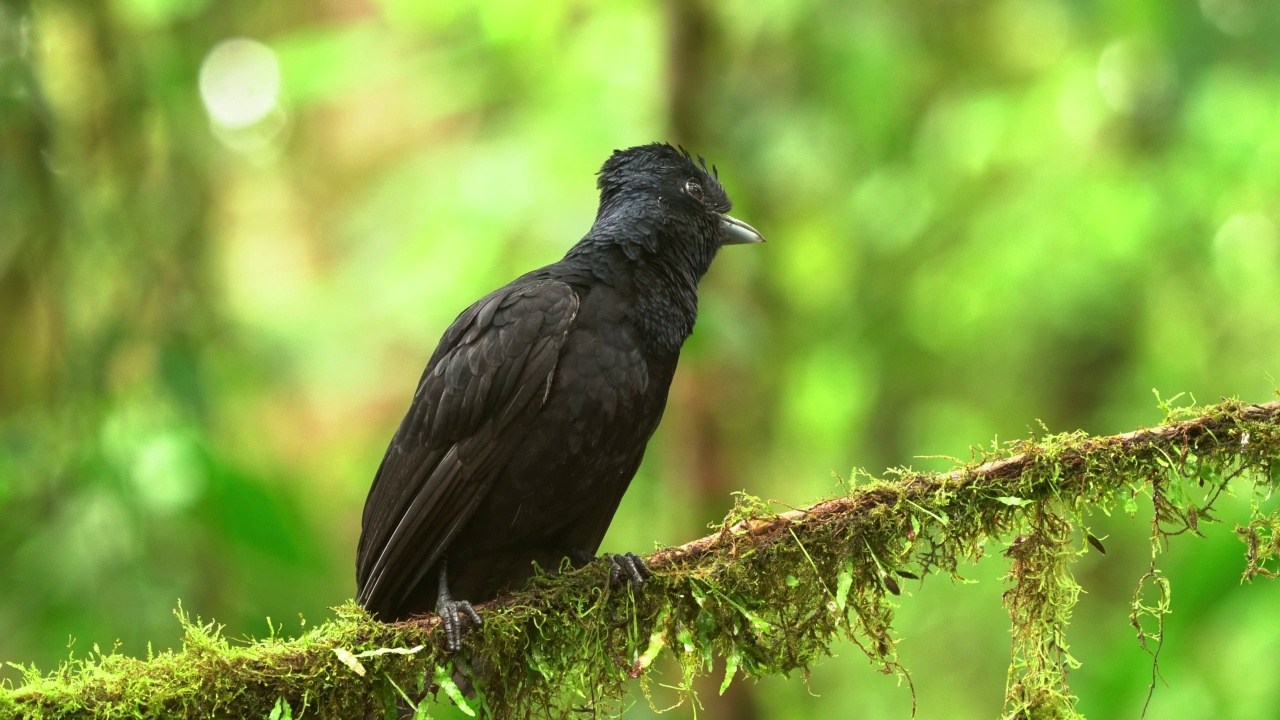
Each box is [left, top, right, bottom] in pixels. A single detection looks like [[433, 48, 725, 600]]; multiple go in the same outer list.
[[356, 143, 764, 650]]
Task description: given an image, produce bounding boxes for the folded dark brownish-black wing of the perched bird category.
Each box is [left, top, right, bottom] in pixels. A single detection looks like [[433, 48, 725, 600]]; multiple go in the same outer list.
[[356, 281, 579, 615]]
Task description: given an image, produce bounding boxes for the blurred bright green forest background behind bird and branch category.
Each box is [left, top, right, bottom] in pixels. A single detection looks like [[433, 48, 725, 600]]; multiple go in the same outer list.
[[0, 0, 1280, 719]]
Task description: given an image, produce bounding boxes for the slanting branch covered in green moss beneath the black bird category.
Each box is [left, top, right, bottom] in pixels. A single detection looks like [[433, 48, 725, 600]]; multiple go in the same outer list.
[[0, 394, 1280, 719]]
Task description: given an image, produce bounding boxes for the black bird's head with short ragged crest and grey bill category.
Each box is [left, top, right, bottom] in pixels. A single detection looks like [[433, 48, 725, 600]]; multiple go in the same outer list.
[[593, 142, 764, 265]]
